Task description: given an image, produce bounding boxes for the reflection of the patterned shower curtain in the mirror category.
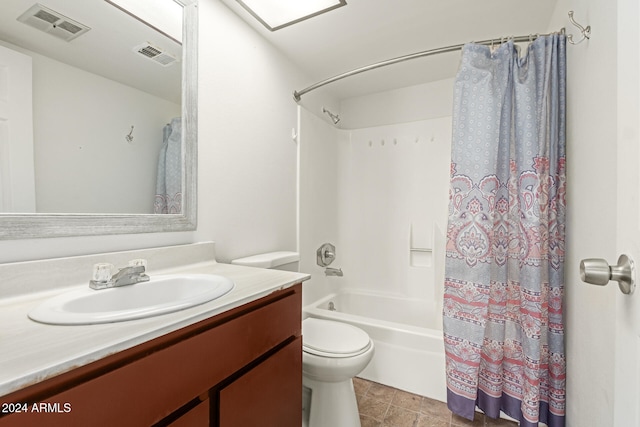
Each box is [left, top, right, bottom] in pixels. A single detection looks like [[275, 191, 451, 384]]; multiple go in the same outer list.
[[153, 117, 182, 214]]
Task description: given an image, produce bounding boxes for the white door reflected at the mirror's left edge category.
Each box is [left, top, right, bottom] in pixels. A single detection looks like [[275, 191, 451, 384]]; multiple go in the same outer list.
[[0, 46, 36, 213]]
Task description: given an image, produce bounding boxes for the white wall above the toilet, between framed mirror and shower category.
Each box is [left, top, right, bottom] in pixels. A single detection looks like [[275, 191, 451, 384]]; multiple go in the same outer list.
[[197, 1, 336, 261]]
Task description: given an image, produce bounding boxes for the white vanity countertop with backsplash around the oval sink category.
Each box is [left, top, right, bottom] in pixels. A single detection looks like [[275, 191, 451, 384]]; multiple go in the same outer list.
[[0, 242, 309, 395]]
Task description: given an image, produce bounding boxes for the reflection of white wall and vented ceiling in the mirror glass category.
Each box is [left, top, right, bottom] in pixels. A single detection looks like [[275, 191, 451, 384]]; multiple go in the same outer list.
[[0, 0, 182, 213]]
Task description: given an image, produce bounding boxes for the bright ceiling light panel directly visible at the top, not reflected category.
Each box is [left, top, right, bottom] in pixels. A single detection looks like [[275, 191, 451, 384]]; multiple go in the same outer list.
[[236, 0, 347, 31]]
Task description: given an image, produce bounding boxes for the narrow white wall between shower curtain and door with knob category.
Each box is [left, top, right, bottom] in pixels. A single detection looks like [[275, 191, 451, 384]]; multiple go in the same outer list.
[[550, 0, 618, 427]]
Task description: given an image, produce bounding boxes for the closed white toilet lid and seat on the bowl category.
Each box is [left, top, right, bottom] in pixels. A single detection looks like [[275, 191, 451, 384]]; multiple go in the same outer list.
[[302, 317, 370, 357]]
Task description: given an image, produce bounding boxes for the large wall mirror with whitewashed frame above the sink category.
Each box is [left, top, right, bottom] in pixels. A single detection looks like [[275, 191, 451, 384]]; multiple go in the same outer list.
[[0, 0, 197, 239]]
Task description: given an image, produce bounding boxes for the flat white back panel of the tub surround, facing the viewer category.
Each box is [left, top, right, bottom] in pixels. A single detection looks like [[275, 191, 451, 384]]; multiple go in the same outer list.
[[336, 118, 451, 299]]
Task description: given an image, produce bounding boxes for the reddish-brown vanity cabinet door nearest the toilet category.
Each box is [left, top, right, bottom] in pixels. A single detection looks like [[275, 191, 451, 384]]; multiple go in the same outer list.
[[219, 337, 302, 427]]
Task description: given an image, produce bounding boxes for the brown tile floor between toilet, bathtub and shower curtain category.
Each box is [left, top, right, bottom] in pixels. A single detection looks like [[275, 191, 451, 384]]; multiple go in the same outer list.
[[353, 378, 517, 427]]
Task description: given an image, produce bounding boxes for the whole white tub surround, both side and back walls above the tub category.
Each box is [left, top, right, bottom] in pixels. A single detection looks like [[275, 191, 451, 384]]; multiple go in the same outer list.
[[299, 108, 451, 304]]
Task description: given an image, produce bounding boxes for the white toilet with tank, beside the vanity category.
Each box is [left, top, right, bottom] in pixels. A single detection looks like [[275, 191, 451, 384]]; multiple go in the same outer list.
[[231, 252, 374, 427]]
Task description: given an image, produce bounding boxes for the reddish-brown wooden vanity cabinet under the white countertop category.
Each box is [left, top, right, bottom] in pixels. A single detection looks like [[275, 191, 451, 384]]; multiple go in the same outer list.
[[0, 284, 302, 427]]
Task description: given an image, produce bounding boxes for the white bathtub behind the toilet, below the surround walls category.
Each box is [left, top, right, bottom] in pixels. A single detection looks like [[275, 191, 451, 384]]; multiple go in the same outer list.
[[303, 290, 446, 402]]
